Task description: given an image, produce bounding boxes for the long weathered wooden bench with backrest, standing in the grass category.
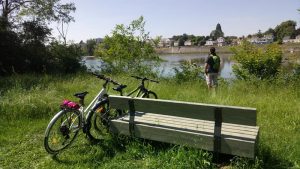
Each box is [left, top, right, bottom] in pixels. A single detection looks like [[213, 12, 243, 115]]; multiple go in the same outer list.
[[109, 96, 259, 158]]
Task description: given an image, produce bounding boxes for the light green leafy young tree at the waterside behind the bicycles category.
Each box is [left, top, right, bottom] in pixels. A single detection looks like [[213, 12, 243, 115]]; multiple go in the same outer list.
[[95, 16, 159, 75]]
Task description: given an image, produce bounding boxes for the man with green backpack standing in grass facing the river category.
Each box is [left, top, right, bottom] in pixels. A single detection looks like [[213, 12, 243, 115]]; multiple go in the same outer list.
[[204, 47, 220, 89]]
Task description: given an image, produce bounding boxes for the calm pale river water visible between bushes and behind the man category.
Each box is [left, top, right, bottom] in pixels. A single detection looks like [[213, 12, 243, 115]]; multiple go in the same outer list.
[[83, 53, 234, 79]]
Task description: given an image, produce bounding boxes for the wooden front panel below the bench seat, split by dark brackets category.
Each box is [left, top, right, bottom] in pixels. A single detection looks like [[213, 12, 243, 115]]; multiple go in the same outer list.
[[110, 120, 255, 158]]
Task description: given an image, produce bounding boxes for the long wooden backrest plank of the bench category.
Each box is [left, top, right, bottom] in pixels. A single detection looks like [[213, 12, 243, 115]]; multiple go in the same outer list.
[[109, 95, 256, 126]]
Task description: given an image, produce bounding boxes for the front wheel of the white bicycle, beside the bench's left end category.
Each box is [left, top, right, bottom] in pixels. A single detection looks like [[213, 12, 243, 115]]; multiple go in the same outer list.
[[86, 103, 109, 142]]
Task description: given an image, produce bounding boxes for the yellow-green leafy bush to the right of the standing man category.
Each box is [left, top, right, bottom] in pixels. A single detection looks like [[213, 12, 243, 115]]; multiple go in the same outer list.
[[232, 41, 282, 80]]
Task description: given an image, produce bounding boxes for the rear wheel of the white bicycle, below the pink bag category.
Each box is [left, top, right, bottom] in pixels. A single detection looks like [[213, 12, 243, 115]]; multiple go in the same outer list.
[[44, 109, 82, 154]]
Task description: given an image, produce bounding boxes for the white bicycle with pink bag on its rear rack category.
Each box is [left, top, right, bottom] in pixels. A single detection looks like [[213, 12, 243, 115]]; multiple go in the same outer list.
[[44, 74, 120, 154]]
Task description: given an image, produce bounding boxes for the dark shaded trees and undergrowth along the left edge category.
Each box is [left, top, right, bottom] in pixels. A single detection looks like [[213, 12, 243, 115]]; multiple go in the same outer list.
[[0, 0, 81, 75]]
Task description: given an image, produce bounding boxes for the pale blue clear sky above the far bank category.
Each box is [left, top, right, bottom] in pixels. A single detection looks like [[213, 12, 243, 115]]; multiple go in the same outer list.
[[52, 0, 300, 43]]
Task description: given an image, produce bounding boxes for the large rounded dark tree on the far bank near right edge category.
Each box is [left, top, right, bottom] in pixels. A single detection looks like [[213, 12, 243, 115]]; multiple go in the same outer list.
[[275, 20, 296, 40]]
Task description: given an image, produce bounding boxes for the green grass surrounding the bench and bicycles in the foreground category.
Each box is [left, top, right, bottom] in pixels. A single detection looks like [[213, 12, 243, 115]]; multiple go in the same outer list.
[[0, 74, 300, 169]]
